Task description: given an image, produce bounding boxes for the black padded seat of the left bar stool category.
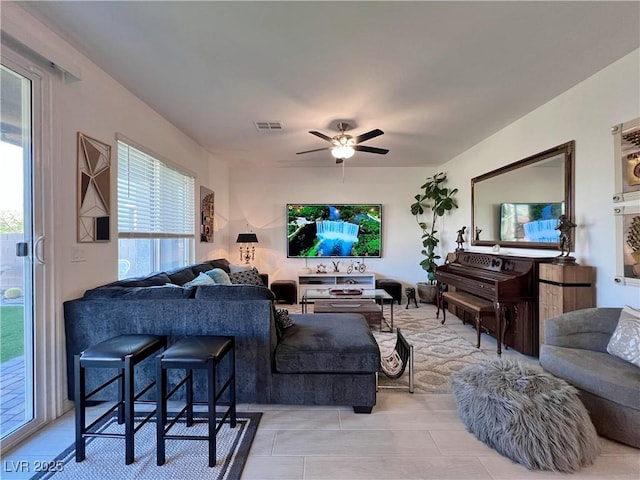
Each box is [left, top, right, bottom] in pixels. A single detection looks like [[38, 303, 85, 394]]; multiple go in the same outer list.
[[80, 334, 166, 366]]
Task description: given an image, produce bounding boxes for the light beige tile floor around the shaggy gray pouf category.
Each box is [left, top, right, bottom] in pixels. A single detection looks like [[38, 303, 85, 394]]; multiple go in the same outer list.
[[0, 316, 640, 480]]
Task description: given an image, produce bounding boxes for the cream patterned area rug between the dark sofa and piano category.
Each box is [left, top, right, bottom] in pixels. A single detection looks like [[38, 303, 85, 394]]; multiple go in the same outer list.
[[288, 304, 493, 393]]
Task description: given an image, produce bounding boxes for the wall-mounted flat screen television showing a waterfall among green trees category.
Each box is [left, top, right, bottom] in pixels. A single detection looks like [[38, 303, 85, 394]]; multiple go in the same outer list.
[[287, 203, 382, 258]]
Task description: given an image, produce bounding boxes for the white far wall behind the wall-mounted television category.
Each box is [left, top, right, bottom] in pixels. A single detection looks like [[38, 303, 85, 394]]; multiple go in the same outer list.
[[230, 166, 438, 285]]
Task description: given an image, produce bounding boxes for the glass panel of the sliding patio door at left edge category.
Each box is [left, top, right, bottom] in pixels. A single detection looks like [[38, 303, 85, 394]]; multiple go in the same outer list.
[[0, 65, 34, 438]]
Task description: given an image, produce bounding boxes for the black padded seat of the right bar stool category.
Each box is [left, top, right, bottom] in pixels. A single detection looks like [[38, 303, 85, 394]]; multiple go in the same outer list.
[[162, 335, 233, 368]]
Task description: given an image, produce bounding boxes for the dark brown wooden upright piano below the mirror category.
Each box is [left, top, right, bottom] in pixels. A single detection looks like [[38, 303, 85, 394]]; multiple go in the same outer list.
[[436, 251, 553, 356]]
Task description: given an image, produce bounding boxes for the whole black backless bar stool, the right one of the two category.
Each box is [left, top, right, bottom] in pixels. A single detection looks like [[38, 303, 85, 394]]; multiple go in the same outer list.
[[156, 335, 236, 467]]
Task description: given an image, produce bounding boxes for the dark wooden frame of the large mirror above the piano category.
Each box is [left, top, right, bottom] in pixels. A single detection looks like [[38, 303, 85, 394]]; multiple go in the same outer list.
[[470, 140, 575, 251]]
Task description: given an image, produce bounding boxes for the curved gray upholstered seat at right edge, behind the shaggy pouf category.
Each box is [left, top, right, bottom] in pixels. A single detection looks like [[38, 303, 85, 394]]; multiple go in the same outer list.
[[540, 308, 640, 448]]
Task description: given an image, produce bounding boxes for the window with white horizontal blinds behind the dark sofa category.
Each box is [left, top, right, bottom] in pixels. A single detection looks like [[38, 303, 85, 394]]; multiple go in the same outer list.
[[118, 140, 195, 278]]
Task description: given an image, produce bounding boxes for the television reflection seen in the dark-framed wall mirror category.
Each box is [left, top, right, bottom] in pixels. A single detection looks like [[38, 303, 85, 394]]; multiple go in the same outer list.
[[500, 202, 564, 243]]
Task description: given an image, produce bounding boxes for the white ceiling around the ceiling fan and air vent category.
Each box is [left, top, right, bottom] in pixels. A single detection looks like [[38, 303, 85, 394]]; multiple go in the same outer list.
[[18, 1, 640, 167]]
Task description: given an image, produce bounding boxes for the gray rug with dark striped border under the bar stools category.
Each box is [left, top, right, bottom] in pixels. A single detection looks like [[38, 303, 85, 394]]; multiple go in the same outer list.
[[31, 412, 262, 480]]
